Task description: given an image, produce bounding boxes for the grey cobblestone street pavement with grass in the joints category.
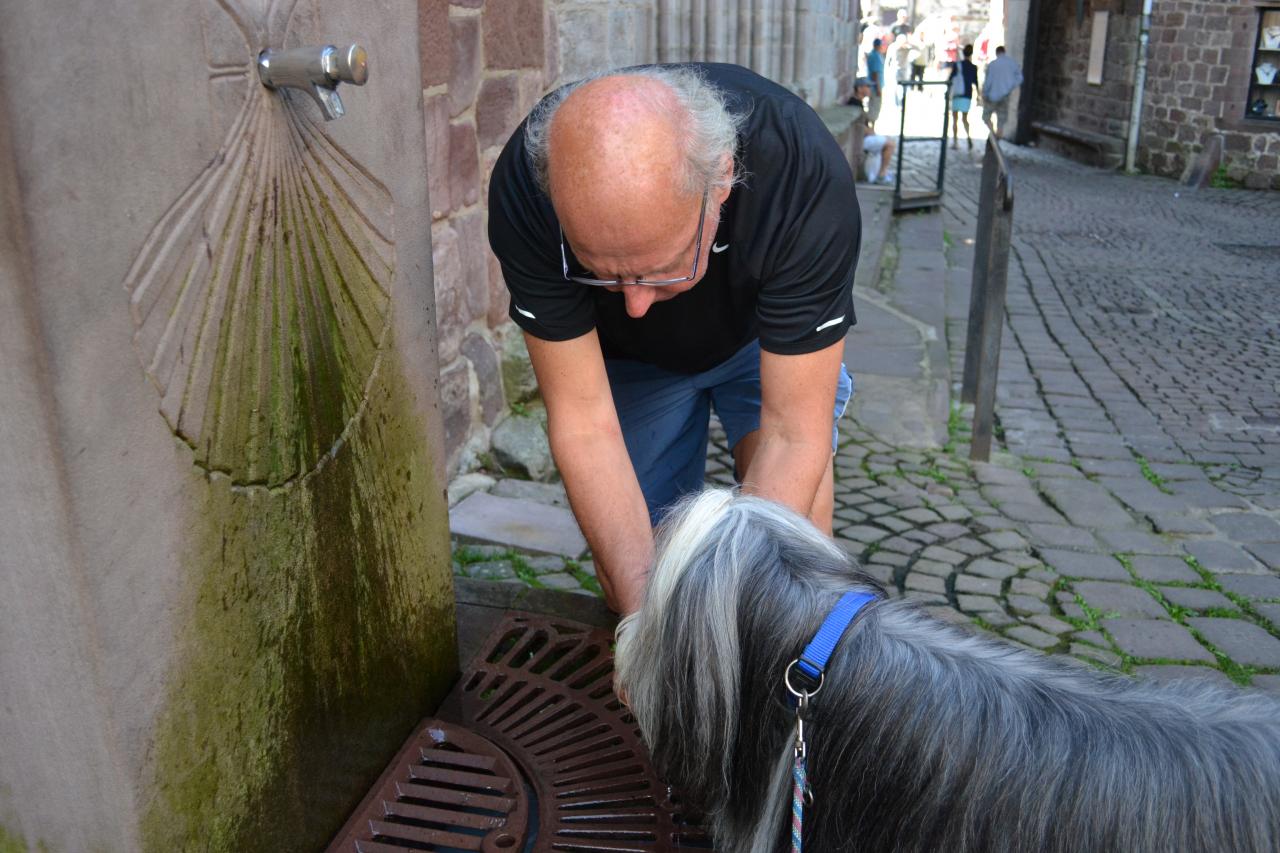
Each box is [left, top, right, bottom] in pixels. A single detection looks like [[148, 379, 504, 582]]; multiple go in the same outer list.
[[445, 136, 1280, 690]]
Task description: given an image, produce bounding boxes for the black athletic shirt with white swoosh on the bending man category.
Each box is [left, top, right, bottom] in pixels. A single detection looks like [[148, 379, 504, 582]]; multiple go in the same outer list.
[[489, 63, 861, 373]]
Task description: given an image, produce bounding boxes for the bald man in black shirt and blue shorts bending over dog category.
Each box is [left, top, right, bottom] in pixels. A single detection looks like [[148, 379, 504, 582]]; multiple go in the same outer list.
[[489, 64, 860, 613]]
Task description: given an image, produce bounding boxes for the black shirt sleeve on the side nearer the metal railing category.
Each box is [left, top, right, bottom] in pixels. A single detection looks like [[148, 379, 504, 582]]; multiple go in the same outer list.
[[756, 101, 861, 355]]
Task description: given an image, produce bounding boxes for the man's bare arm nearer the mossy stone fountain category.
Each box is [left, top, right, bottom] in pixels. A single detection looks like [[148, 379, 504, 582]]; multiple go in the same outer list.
[[525, 330, 653, 615]]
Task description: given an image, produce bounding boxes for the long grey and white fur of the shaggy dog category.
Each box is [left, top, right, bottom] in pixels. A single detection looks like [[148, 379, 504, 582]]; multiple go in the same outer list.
[[617, 491, 1280, 853]]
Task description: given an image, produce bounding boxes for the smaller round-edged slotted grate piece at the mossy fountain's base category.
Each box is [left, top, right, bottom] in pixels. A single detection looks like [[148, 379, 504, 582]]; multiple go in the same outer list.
[[329, 720, 529, 853]]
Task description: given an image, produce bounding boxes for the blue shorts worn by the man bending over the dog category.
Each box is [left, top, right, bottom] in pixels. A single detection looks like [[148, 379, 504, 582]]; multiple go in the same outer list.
[[604, 341, 854, 524]]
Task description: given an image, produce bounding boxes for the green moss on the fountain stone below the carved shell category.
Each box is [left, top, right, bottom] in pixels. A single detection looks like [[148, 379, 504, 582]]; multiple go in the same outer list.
[[142, 347, 457, 853]]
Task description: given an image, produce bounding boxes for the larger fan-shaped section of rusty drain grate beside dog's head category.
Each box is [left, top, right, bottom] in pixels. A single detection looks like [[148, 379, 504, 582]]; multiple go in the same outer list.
[[440, 612, 712, 853]]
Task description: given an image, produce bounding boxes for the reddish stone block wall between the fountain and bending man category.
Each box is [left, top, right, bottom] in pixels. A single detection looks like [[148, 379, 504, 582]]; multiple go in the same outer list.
[[419, 0, 654, 473]]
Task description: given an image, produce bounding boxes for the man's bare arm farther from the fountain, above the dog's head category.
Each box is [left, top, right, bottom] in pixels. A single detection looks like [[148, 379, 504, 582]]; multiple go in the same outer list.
[[742, 341, 845, 528]]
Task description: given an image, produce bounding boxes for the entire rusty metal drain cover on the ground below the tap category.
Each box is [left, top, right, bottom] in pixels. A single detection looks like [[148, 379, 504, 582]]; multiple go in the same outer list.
[[329, 611, 712, 853]]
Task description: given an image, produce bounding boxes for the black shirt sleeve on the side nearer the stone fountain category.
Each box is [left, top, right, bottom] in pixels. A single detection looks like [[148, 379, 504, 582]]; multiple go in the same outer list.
[[489, 124, 595, 341]]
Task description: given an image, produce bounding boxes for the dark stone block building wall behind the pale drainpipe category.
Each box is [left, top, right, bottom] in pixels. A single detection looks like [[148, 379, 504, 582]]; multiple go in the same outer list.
[[1033, 0, 1280, 188]]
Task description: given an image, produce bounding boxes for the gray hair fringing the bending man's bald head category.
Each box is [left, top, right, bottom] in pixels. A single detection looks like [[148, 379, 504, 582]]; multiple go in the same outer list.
[[525, 65, 746, 196]]
